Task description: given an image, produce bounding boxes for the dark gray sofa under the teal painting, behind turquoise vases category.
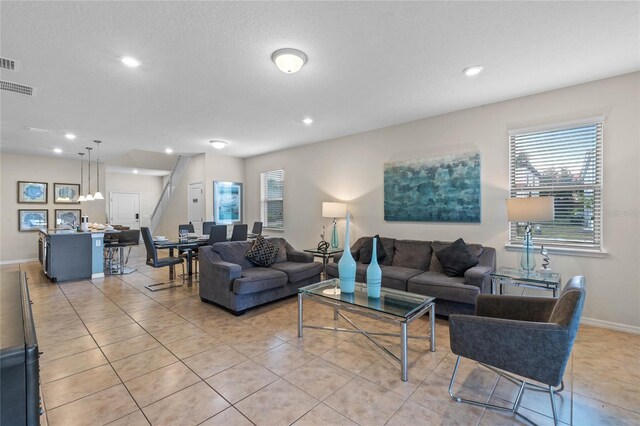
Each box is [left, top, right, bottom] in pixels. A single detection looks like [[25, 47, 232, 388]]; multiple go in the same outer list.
[[327, 237, 496, 317]]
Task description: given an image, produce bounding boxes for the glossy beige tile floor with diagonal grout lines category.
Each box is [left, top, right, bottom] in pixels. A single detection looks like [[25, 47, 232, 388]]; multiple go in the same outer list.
[[2, 246, 640, 425]]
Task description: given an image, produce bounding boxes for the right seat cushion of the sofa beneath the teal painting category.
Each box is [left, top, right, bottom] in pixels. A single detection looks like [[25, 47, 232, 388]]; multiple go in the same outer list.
[[407, 271, 480, 306]]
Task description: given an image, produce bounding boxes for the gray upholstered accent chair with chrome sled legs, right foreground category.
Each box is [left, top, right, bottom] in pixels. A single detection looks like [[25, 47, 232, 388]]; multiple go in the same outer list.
[[449, 276, 586, 425]]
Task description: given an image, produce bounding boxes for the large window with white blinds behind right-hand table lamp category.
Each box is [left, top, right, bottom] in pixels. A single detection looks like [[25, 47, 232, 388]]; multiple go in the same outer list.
[[509, 119, 603, 251]]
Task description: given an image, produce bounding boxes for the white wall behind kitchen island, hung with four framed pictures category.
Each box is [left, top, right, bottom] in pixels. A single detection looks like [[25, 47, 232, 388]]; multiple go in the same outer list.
[[0, 154, 106, 262]]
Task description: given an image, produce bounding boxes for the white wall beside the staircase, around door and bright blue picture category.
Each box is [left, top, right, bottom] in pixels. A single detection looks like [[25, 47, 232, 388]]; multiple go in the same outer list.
[[155, 153, 247, 238]]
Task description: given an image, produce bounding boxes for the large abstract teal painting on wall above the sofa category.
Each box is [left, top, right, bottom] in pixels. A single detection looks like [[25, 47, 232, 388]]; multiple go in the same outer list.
[[384, 152, 480, 223]]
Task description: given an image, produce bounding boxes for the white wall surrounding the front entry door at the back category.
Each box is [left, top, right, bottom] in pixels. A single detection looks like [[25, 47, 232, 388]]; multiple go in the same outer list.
[[103, 173, 163, 226]]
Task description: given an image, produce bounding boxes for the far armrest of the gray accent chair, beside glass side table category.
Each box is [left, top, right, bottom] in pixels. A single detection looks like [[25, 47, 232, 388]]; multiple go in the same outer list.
[[476, 294, 556, 322]]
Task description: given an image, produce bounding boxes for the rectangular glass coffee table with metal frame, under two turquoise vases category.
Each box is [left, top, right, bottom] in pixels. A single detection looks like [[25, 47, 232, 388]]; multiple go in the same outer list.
[[298, 278, 436, 382]]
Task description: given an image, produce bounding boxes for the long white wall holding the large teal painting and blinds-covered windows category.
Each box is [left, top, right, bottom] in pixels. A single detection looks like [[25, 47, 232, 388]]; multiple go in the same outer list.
[[245, 73, 640, 327]]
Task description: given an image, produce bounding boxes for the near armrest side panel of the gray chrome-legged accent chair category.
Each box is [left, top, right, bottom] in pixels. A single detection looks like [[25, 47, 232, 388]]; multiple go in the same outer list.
[[449, 314, 570, 386]]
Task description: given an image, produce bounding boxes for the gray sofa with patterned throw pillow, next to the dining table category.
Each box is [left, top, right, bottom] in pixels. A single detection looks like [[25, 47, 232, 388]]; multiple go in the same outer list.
[[198, 238, 322, 315]]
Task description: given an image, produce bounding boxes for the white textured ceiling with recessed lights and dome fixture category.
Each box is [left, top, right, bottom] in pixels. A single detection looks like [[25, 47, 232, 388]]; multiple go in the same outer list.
[[0, 1, 640, 165]]
